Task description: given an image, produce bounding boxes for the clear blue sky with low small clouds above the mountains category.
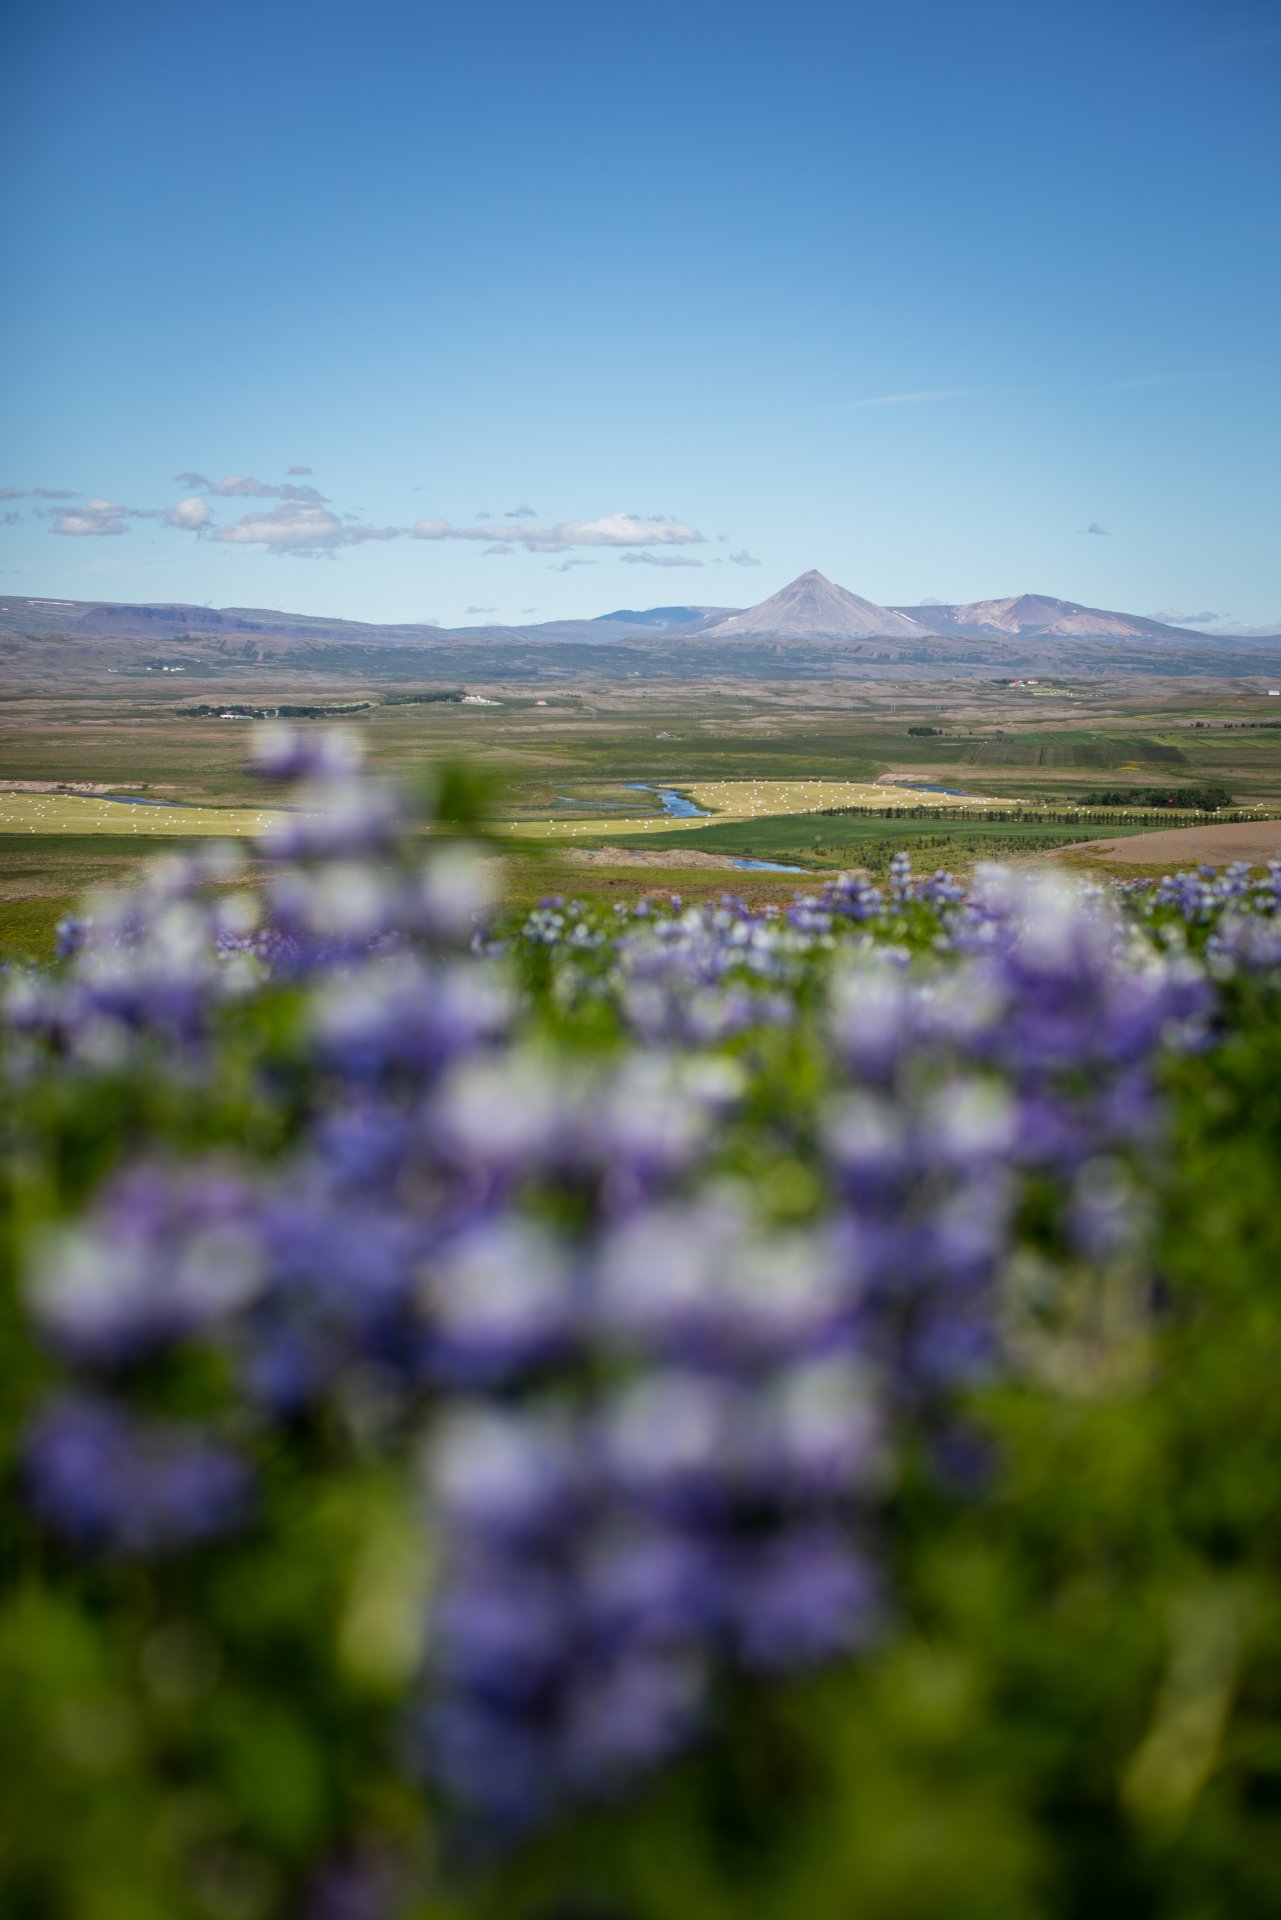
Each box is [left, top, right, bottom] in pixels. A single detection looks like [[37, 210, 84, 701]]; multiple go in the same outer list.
[[0, 0, 1281, 630]]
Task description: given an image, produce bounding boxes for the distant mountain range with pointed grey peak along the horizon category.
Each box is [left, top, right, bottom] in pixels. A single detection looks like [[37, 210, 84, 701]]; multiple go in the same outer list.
[[0, 570, 1281, 678]]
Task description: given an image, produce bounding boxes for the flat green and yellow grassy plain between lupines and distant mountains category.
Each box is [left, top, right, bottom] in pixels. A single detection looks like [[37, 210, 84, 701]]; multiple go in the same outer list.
[[0, 670, 1281, 952]]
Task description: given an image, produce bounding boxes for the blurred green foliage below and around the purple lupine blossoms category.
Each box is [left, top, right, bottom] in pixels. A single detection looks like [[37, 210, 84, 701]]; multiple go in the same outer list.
[[0, 814, 1281, 1920]]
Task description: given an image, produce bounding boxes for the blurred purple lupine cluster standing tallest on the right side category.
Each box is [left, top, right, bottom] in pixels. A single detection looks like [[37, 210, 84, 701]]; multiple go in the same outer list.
[[822, 876, 1210, 1448]]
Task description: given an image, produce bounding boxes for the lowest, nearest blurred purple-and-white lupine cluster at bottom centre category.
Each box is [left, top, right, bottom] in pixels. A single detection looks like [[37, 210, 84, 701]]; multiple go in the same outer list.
[[423, 1192, 885, 1834]]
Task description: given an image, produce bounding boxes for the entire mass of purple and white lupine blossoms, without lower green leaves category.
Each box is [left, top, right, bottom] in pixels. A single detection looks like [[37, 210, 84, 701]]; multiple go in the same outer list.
[[4, 733, 1281, 1836]]
